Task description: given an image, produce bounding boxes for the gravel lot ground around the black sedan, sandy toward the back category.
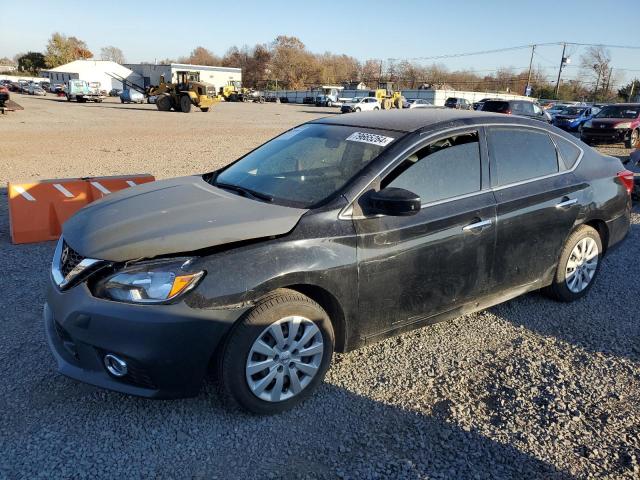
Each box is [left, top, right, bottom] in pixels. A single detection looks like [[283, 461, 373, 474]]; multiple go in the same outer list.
[[0, 96, 640, 479]]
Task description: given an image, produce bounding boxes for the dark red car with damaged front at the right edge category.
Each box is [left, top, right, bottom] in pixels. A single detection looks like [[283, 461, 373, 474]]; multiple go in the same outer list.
[[580, 103, 640, 148]]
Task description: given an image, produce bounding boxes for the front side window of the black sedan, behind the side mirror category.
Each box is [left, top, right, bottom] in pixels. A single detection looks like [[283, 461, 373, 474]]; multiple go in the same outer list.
[[381, 131, 481, 204]]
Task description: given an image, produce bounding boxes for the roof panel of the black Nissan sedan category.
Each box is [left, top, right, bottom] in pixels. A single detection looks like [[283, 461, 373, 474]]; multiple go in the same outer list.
[[309, 108, 524, 133]]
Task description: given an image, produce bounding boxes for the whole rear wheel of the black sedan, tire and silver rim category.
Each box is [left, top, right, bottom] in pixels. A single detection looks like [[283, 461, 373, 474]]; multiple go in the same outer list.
[[546, 225, 603, 302]]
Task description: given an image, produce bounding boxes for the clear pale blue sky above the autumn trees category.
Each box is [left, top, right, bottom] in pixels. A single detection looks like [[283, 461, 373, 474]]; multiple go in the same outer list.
[[0, 0, 640, 86]]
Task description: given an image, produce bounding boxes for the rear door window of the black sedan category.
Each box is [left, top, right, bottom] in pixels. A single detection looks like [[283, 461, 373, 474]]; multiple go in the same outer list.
[[487, 128, 558, 186]]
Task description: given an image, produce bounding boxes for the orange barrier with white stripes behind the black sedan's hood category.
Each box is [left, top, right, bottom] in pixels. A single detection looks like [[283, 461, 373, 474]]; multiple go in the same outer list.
[[7, 175, 155, 243]]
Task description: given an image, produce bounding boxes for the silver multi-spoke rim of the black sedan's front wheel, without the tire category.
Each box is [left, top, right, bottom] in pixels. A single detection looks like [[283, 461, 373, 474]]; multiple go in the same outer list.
[[245, 315, 324, 402]]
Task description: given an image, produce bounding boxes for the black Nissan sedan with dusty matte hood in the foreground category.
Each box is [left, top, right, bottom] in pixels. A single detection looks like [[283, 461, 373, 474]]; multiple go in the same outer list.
[[44, 109, 633, 414]]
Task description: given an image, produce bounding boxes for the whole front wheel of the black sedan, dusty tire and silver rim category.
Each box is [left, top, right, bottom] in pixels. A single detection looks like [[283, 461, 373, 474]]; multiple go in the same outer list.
[[217, 289, 335, 415]]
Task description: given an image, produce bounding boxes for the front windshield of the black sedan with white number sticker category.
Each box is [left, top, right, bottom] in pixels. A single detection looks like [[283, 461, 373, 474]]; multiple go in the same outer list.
[[212, 124, 398, 208]]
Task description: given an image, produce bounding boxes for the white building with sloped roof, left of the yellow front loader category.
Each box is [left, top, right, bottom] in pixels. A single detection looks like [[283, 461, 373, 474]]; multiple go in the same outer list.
[[41, 60, 142, 92]]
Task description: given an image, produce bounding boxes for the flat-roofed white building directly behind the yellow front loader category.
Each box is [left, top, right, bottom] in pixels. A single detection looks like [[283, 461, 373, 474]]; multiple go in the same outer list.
[[126, 63, 242, 92]]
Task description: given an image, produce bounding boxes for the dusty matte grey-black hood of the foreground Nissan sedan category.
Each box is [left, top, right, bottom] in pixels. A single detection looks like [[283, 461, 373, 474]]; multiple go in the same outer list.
[[62, 176, 307, 262]]
